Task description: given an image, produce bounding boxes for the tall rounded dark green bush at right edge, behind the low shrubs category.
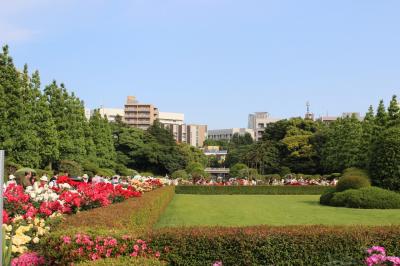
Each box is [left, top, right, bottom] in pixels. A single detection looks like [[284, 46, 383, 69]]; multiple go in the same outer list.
[[370, 126, 400, 191]]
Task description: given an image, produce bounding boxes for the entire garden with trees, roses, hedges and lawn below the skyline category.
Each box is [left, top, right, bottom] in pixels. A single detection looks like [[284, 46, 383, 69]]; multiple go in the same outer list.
[[0, 46, 400, 266]]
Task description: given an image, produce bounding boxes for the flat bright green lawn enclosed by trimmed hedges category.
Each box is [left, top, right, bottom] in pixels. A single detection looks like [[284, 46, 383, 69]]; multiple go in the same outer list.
[[156, 195, 400, 228]]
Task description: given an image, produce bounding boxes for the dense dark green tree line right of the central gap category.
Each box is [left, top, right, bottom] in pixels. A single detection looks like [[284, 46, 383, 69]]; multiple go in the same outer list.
[[226, 96, 400, 190]]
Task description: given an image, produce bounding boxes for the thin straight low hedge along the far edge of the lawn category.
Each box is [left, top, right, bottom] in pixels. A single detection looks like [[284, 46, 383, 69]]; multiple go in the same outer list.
[[175, 186, 328, 195]]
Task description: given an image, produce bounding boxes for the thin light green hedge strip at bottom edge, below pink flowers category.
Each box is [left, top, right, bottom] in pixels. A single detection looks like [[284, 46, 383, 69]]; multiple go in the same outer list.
[[76, 257, 166, 266]]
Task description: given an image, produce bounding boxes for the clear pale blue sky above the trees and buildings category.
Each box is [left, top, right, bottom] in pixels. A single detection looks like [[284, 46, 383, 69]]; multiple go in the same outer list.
[[0, 0, 400, 129]]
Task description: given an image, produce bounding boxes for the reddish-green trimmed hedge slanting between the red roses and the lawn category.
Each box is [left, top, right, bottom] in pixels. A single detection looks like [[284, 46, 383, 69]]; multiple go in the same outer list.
[[53, 186, 174, 236]]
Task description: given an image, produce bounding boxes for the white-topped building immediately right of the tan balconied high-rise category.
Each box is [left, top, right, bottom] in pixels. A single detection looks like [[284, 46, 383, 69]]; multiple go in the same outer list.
[[158, 112, 187, 143]]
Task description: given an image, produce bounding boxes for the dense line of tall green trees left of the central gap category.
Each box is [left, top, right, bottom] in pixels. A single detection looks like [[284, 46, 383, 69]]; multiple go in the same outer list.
[[0, 46, 207, 175]]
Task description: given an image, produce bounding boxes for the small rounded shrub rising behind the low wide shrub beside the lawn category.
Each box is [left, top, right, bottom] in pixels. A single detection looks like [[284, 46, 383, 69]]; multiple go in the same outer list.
[[336, 168, 371, 192]]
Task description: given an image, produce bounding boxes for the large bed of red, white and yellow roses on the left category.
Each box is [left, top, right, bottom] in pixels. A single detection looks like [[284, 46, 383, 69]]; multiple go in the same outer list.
[[3, 177, 162, 261]]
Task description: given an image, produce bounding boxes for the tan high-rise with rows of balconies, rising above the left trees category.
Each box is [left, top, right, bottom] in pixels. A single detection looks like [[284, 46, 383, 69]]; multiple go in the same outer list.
[[124, 96, 158, 130]]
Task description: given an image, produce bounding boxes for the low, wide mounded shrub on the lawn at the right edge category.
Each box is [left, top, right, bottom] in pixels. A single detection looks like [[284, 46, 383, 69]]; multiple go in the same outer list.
[[331, 187, 400, 209]]
